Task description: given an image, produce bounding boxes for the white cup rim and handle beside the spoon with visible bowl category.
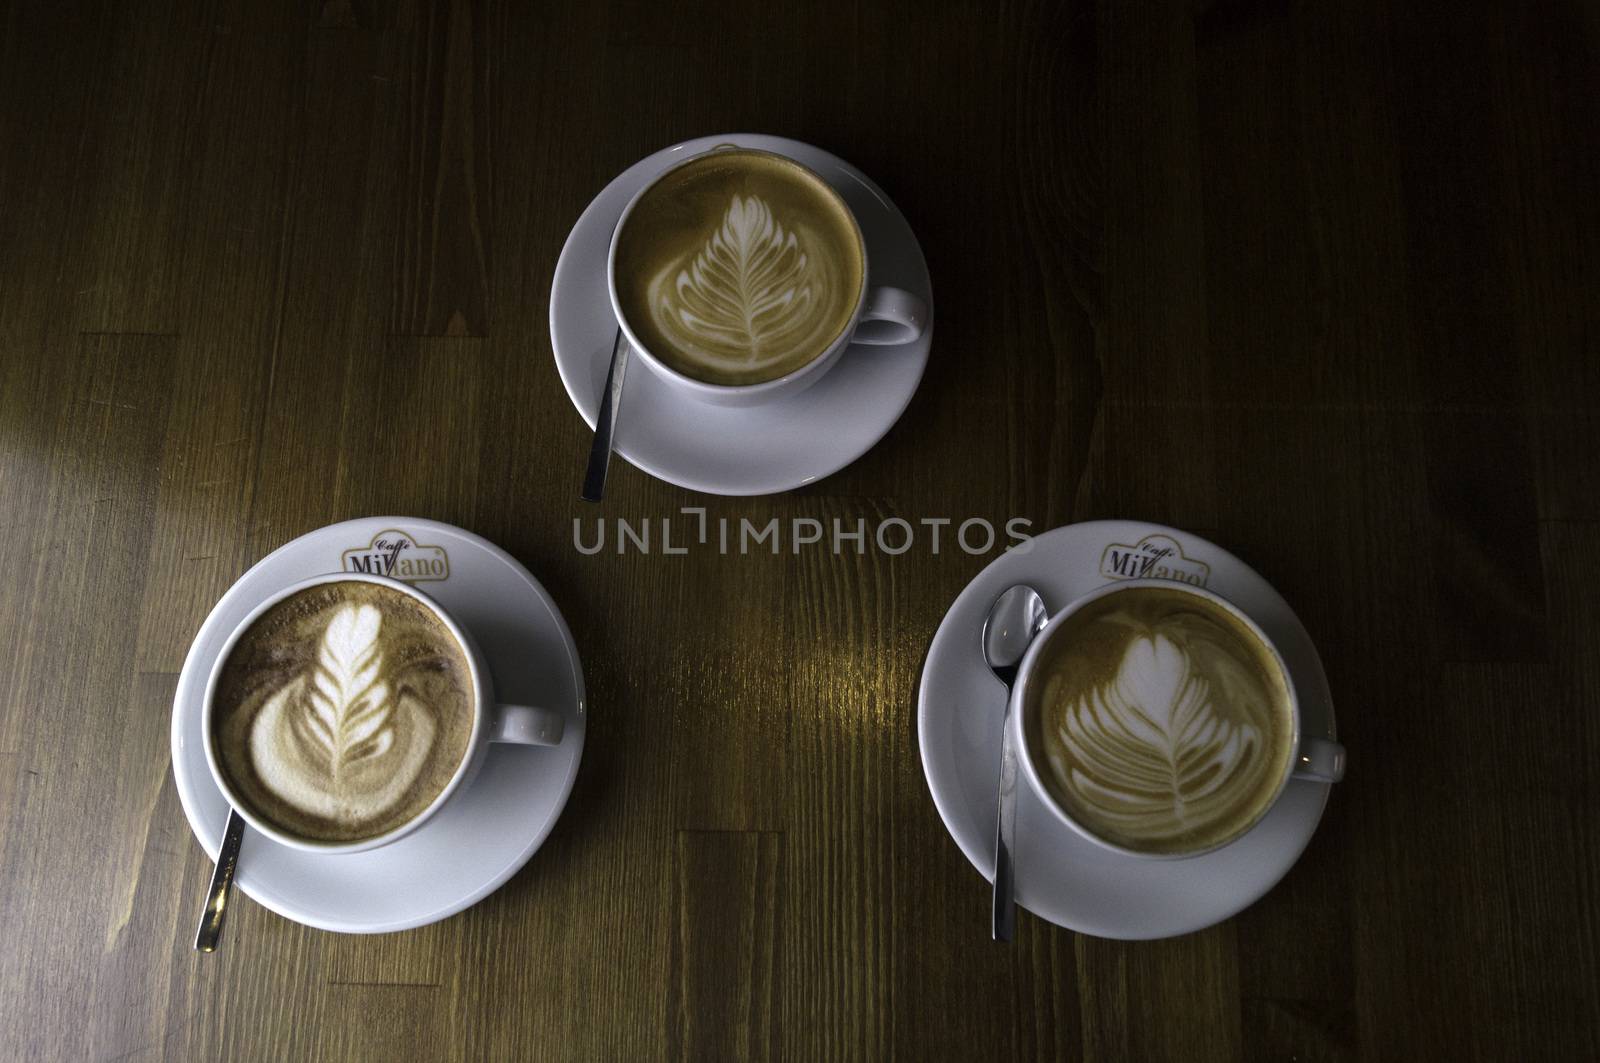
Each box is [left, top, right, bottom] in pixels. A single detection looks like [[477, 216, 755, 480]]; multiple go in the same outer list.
[[1006, 580, 1344, 860]]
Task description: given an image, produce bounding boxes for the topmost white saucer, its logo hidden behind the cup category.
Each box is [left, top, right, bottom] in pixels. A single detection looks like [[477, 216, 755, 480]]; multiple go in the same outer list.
[[550, 133, 933, 495]]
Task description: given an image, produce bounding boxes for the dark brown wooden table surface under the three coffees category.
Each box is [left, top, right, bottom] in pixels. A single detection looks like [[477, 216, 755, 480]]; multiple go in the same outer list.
[[0, 0, 1600, 1060]]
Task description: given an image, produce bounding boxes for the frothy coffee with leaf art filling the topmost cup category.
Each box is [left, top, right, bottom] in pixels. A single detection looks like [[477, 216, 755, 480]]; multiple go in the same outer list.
[[616, 149, 866, 384]]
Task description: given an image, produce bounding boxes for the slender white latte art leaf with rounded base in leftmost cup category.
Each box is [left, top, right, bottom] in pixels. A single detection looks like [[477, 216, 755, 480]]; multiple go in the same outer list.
[[250, 605, 435, 824]]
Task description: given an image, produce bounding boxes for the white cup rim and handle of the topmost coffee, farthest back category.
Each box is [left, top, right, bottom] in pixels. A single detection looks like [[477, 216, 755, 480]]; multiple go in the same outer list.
[[606, 144, 928, 407]]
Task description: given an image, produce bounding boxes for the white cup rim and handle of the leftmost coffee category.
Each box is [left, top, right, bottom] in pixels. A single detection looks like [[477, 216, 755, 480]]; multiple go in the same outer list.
[[200, 572, 565, 853]]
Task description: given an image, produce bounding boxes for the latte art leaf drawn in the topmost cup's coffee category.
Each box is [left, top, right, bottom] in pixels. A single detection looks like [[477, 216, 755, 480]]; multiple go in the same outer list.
[[658, 195, 818, 363]]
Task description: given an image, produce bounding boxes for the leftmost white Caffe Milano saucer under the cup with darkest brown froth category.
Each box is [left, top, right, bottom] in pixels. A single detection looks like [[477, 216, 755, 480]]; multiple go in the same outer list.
[[173, 517, 586, 933]]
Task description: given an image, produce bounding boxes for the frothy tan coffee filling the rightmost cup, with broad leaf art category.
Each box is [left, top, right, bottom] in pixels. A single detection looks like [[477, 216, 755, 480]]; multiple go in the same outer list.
[[1022, 588, 1294, 853]]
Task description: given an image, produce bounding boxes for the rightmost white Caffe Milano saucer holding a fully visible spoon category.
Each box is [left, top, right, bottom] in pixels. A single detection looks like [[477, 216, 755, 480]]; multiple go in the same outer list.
[[917, 520, 1334, 938]]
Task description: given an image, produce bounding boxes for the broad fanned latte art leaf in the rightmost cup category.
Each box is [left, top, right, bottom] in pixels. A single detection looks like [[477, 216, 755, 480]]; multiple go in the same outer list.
[[1059, 634, 1262, 837]]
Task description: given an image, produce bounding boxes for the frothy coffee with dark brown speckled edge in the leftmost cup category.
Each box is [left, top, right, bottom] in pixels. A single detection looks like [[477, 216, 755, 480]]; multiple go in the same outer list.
[[211, 580, 474, 842]]
